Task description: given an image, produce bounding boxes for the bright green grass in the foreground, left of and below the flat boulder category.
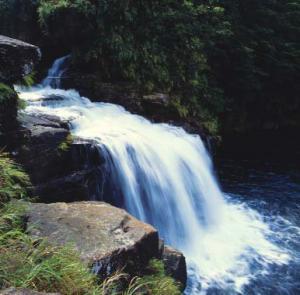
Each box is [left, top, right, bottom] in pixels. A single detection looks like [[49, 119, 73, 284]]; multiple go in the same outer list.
[[0, 152, 180, 295]]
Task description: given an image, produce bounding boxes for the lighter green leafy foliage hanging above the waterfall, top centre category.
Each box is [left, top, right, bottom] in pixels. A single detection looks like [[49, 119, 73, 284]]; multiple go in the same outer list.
[[39, 0, 230, 132]]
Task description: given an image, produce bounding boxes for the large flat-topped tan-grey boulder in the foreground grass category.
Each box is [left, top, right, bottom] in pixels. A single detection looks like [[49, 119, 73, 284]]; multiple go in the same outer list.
[[26, 202, 159, 277]]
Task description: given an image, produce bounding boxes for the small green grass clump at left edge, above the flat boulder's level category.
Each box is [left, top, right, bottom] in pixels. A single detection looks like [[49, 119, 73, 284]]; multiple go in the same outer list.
[[0, 152, 30, 207]]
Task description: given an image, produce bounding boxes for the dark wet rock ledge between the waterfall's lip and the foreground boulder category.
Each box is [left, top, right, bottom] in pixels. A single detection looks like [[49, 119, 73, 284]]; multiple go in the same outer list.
[[18, 113, 103, 203]]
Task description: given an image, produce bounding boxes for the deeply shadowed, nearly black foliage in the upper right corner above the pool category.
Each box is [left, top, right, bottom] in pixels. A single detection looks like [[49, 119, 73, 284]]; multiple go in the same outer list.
[[208, 0, 300, 132]]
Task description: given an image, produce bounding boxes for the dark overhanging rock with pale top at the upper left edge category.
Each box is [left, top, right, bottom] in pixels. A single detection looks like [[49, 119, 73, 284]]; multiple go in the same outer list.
[[0, 35, 41, 83]]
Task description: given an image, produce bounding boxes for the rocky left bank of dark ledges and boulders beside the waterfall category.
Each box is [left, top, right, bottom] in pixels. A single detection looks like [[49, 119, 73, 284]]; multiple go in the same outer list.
[[0, 36, 187, 294]]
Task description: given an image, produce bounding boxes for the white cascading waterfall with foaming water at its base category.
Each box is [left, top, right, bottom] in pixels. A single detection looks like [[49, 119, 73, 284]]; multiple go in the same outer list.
[[18, 57, 290, 294]]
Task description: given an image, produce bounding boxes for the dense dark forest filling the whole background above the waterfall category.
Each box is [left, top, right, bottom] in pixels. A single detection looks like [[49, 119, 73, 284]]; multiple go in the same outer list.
[[0, 0, 300, 133]]
